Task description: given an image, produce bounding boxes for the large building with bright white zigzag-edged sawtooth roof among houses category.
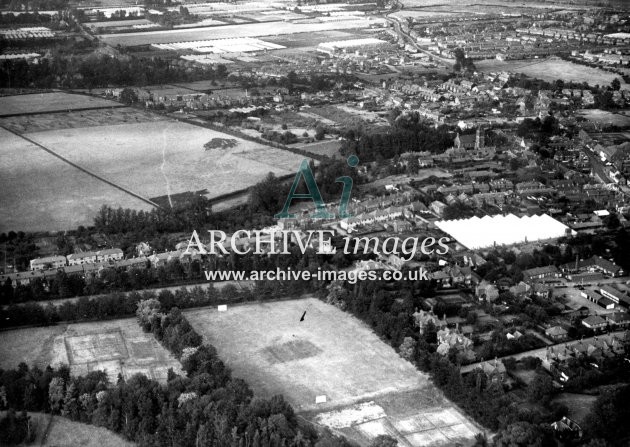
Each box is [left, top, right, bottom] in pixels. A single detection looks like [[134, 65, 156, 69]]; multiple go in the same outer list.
[[435, 214, 572, 249]]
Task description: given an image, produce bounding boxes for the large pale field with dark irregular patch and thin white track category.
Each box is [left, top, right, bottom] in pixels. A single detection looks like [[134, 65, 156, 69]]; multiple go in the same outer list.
[[29, 120, 302, 201]]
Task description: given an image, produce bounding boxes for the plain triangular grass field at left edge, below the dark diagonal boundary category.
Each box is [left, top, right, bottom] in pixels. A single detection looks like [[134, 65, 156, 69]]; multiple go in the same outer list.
[[0, 128, 149, 232]]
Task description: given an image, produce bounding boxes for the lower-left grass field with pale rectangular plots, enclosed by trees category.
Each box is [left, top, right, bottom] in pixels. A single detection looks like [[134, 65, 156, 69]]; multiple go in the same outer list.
[[0, 318, 181, 382]]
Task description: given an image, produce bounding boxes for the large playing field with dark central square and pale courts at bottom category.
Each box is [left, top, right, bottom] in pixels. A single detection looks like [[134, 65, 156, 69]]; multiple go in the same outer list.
[[185, 298, 479, 447]]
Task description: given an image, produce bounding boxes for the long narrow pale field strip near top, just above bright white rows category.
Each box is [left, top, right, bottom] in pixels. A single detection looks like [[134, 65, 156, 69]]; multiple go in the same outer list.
[[99, 18, 388, 47]]
